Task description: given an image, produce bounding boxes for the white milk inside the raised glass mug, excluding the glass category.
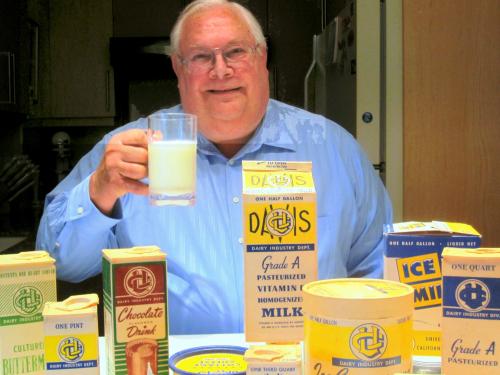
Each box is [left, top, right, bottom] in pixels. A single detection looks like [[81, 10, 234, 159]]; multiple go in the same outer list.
[[148, 140, 196, 195]]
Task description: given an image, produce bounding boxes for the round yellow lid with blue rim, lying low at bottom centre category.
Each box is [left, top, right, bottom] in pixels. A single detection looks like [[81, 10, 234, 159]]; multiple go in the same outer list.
[[168, 345, 247, 375]]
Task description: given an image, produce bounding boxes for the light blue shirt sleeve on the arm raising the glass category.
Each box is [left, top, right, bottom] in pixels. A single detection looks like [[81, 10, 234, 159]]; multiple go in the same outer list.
[[36, 141, 121, 282]]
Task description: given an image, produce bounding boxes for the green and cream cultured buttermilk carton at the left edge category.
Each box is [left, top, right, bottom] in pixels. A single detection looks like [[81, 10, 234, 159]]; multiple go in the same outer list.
[[0, 251, 57, 375]]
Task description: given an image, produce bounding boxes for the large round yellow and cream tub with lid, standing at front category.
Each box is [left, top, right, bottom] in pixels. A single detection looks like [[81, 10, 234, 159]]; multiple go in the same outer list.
[[303, 278, 414, 375]]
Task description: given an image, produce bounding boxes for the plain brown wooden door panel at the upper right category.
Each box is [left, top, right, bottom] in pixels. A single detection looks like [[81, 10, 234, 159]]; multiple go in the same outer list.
[[403, 0, 500, 247]]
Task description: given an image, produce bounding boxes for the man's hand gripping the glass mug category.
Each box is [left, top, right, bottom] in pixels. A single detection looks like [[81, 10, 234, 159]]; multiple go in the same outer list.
[[90, 129, 148, 215]]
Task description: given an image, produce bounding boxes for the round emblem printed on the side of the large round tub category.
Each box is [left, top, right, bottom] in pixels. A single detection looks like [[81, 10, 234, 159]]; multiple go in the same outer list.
[[349, 323, 387, 361]]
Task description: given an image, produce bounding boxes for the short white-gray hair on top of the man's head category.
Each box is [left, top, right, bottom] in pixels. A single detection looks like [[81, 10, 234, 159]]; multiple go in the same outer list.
[[170, 0, 267, 55]]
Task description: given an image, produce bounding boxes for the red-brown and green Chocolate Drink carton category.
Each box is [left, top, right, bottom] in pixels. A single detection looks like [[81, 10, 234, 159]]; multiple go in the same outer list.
[[102, 246, 168, 375]]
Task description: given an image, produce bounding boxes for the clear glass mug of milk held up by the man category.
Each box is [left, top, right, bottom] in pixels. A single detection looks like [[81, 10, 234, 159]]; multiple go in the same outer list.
[[148, 112, 197, 206]]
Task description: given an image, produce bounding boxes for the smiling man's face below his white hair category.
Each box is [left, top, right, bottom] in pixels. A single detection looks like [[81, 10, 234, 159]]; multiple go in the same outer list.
[[172, 7, 269, 150]]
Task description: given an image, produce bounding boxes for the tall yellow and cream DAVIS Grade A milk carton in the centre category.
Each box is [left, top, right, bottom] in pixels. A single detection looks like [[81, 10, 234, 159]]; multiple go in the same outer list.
[[243, 161, 317, 343]]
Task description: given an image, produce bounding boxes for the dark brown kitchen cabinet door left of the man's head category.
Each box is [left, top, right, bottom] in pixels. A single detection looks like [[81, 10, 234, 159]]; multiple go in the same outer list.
[[40, 0, 114, 119]]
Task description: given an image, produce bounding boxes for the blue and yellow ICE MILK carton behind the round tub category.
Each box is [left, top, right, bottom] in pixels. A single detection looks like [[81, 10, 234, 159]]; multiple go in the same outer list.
[[384, 221, 481, 356]]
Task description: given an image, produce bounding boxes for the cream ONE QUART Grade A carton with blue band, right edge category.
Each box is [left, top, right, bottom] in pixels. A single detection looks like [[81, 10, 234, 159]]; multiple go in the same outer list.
[[442, 248, 500, 375]]
